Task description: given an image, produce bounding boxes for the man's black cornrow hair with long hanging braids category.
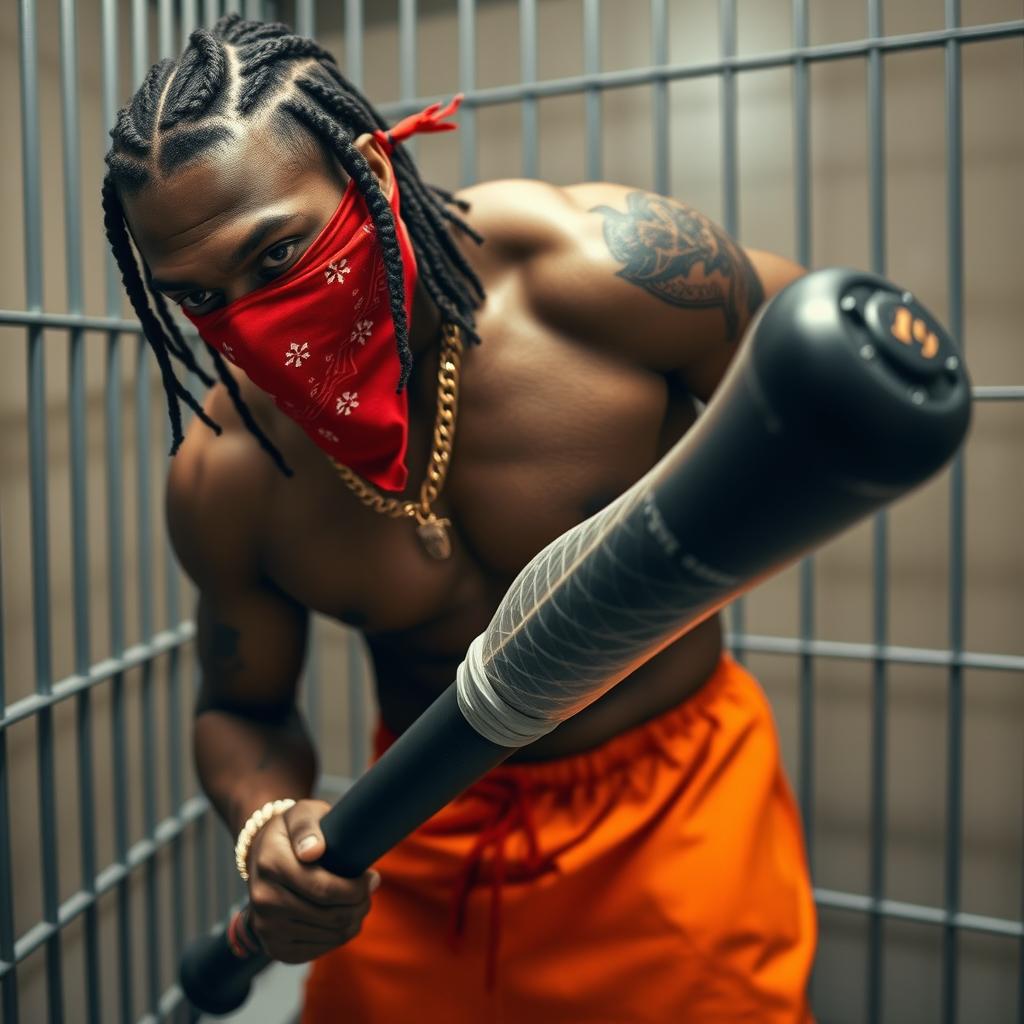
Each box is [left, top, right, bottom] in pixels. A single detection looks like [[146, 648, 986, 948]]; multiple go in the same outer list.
[[102, 14, 484, 476]]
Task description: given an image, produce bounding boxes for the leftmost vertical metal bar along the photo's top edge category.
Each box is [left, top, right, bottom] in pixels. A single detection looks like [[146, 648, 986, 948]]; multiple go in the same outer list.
[[18, 0, 63, 1021]]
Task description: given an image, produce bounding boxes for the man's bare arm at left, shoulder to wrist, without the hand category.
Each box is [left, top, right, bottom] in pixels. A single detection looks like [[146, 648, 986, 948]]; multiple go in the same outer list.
[[167, 434, 316, 834]]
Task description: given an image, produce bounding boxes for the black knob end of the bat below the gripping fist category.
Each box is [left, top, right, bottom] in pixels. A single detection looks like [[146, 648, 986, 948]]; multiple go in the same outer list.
[[178, 909, 270, 1015]]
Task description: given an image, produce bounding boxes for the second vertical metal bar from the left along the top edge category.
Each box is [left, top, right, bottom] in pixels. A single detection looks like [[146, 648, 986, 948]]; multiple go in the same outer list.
[[60, 0, 100, 1011]]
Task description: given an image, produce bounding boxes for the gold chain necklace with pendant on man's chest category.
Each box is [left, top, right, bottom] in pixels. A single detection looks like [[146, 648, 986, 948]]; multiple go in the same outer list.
[[331, 324, 463, 559]]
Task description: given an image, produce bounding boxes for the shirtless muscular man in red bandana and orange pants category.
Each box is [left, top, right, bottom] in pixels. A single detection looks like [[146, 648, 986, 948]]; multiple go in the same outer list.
[[103, 15, 816, 1024]]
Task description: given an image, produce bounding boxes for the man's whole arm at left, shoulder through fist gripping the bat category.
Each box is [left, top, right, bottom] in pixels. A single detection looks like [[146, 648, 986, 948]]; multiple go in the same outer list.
[[167, 431, 379, 964]]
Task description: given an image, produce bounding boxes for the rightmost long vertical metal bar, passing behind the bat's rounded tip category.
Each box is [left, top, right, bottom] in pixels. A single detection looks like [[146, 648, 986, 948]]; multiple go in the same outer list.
[[942, 0, 966, 1024]]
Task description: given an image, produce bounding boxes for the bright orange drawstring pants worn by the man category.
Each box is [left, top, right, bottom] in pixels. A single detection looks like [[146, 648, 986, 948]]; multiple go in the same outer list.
[[302, 656, 817, 1024]]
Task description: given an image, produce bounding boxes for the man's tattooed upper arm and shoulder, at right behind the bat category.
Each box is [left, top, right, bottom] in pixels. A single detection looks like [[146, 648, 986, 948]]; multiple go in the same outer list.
[[516, 182, 805, 401]]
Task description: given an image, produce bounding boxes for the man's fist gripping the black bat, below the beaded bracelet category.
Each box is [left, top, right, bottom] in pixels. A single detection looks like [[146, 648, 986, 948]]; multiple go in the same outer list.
[[242, 800, 380, 964]]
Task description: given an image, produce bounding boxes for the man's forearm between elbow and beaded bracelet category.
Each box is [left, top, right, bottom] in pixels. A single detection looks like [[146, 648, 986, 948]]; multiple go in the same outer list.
[[193, 708, 316, 835]]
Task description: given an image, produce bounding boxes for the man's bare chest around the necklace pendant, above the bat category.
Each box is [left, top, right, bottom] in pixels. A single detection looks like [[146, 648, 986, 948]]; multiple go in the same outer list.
[[256, 296, 693, 642]]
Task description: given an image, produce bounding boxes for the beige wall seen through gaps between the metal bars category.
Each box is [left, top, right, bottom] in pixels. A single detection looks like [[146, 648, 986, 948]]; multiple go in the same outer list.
[[0, 0, 1024, 1022]]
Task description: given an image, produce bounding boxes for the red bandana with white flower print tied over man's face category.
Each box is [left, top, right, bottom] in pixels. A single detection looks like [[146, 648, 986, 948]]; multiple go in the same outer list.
[[183, 96, 462, 492]]
